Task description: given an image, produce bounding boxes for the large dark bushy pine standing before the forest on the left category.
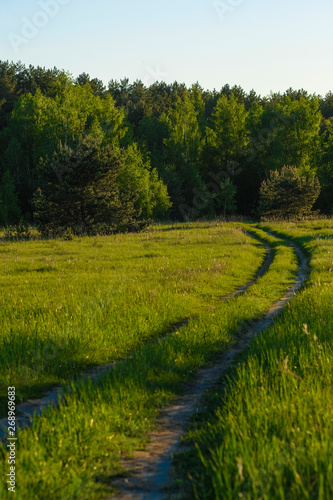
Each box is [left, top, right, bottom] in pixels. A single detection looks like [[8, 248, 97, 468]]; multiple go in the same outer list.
[[34, 136, 140, 233]]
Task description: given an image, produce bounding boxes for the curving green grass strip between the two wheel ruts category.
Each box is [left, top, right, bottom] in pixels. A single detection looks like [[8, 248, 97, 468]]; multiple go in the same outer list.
[[0, 226, 297, 500]]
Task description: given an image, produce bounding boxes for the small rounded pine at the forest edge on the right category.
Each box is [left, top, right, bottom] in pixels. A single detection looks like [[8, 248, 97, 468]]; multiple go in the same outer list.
[[259, 165, 320, 220]]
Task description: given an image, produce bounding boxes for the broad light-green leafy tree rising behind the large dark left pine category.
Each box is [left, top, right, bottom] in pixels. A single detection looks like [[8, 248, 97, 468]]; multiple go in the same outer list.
[[2, 84, 126, 217]]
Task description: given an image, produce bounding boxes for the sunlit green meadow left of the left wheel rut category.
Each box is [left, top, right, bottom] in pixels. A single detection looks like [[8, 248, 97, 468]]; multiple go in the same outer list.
[[0, 224, 264, 416]]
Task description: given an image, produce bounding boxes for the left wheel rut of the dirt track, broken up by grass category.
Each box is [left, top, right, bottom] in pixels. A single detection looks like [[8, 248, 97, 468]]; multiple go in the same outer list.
[[0, 233, 273, 441]]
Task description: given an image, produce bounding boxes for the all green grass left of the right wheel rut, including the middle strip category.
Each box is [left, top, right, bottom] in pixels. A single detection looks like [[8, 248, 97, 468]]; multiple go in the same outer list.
[[0, 223, 316, 500]]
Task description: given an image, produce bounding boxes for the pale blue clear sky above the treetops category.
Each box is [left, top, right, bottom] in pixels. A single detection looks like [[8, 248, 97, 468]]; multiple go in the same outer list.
[[0, 0, 333, 96]]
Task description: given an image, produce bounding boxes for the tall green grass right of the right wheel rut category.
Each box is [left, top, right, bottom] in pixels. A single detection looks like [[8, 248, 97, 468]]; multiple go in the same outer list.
[[177, 221, 333, 500]]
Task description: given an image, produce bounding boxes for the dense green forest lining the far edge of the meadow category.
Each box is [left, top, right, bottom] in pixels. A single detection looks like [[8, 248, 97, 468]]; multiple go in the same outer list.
[[0, 61, 333, 232]]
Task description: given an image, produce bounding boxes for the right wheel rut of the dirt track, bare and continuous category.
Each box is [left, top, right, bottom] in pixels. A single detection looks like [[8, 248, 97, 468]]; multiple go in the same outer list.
[[105, 231, 308, 500]]
